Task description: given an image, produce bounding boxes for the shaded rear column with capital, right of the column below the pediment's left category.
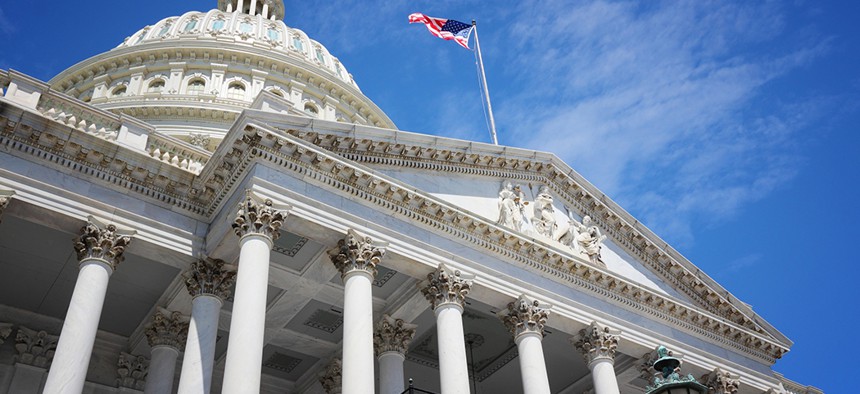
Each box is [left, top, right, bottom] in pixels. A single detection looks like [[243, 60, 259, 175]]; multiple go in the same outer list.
[[373, 315, 417, 394]]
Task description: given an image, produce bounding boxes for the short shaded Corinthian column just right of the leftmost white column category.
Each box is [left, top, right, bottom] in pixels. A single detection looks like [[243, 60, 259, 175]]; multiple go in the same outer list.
[[144, 308, 188, 394]]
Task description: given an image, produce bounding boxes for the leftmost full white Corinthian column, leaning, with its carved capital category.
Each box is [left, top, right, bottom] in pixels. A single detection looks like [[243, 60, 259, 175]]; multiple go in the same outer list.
[[44, 217, 134, 394]]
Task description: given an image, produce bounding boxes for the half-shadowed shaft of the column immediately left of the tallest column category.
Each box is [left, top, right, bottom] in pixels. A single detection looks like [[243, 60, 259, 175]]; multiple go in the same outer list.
[[179, 294, 221, 394]]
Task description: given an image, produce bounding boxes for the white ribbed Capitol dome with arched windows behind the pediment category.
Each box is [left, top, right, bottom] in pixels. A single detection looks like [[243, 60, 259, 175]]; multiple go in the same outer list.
[[49, 0, 395, 150]]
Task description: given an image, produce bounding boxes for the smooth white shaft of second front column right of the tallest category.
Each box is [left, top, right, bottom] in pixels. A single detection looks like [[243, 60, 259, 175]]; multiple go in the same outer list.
[[435, 303, 469, 394]]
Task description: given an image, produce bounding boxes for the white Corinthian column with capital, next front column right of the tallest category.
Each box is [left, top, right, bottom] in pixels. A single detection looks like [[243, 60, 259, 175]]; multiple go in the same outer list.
[[329, 229, 385, 394]]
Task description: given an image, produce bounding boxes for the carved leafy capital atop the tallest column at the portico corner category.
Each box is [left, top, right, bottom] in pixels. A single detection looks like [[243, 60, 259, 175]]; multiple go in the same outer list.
[[233, 190, 290, 241]]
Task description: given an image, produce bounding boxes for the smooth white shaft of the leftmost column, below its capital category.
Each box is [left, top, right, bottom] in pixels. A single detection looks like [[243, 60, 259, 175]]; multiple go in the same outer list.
[[44, 259, 113, 394]]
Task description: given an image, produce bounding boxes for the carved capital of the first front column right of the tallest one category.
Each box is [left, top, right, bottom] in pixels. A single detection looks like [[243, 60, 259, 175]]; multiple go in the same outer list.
[[328, 229, 387, 278]]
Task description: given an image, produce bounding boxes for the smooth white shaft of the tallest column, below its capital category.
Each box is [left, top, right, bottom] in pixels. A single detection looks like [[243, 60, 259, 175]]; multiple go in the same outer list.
[[223, 233, 272, 394]]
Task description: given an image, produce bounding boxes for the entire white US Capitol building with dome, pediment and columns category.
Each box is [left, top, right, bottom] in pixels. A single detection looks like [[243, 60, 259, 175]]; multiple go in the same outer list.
[[0, 0, 821, 394]]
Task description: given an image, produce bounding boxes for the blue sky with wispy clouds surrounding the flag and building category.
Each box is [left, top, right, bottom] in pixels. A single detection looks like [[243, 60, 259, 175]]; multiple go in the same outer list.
[[0, 0, 860, 393]]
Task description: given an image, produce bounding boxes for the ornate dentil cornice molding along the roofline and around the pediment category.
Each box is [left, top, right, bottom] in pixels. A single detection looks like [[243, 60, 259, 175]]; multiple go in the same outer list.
[[0, 93, 789, 363]]
